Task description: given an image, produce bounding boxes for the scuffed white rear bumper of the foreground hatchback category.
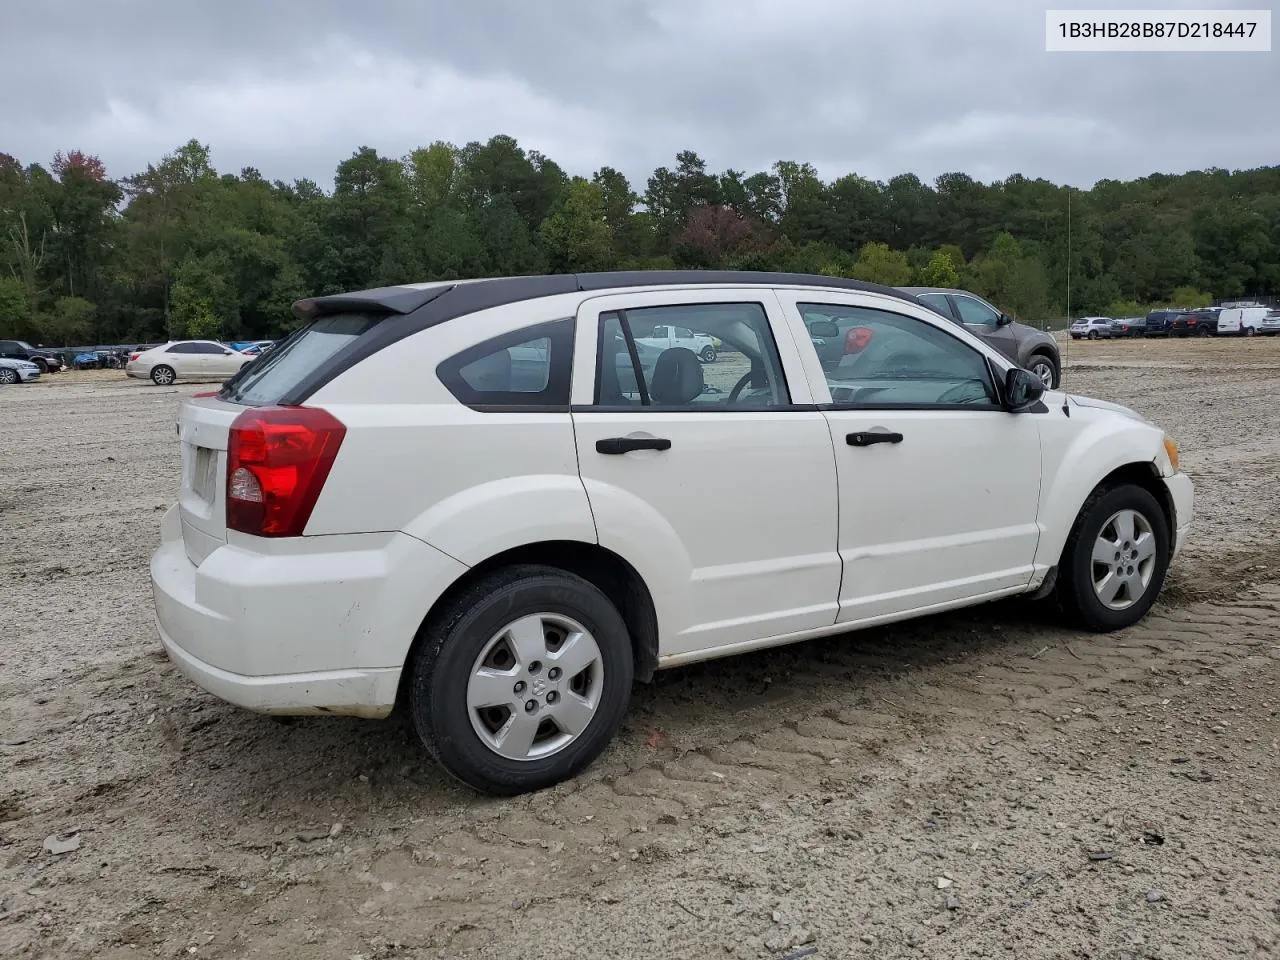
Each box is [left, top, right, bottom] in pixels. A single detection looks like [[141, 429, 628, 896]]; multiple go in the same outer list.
[[151, 507, 466, 717]]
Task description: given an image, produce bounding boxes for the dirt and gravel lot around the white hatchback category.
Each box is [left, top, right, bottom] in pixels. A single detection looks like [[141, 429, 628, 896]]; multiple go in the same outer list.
[[0, 339, 1280, 960]]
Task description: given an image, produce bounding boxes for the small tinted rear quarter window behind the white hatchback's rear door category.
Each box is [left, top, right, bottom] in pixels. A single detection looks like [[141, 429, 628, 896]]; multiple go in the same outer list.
[[435, 319, 573, 410]]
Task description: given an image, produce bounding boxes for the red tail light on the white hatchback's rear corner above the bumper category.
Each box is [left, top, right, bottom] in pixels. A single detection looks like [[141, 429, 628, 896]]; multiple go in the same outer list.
[[227, 407, 347, 536]]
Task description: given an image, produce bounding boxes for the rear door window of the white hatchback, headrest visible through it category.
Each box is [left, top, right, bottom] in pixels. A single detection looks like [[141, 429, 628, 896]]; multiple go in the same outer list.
[[595, 303, 791, 411]]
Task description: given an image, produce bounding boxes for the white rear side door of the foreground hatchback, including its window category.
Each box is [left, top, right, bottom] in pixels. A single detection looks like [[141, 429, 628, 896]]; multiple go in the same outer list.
[[572, 287, 840, 662]]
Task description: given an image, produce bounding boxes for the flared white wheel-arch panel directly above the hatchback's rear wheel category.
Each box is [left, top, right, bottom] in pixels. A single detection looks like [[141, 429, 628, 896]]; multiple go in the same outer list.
[[402, 474, 596, 567]]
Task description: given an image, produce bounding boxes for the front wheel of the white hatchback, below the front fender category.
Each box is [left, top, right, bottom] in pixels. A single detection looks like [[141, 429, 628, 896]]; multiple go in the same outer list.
[[1057, 484, 1169, 634]]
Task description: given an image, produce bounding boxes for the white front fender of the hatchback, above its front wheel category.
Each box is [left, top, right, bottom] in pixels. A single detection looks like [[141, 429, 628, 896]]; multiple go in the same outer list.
[[1036, 406, 1165, 570]]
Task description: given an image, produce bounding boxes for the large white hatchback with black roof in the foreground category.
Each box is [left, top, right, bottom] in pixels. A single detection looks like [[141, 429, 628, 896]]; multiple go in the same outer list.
[[151, 271, 1193, 794]]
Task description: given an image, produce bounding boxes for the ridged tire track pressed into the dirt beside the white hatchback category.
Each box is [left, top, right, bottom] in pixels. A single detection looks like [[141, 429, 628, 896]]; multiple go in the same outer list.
[[82, 588, 1280, 956]]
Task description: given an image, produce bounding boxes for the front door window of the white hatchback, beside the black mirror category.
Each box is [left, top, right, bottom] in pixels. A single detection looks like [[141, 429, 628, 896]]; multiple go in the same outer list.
[[797, 303, 998, 407]]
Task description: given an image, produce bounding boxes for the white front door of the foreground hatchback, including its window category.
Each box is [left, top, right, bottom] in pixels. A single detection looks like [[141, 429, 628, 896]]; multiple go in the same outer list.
[[778, 291, 1041, 623]]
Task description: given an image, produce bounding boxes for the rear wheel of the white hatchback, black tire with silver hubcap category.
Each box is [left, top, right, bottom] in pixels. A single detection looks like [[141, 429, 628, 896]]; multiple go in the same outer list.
[[408, 564, 635, 796]]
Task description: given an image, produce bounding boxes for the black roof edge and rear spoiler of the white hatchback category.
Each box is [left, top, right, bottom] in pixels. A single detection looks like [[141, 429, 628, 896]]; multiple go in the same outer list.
[[280, 270, 936, 404]]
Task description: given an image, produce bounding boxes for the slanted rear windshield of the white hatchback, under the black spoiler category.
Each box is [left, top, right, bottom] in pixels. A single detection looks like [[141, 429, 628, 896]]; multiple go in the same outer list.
[[219, 314, 383, 407]]
